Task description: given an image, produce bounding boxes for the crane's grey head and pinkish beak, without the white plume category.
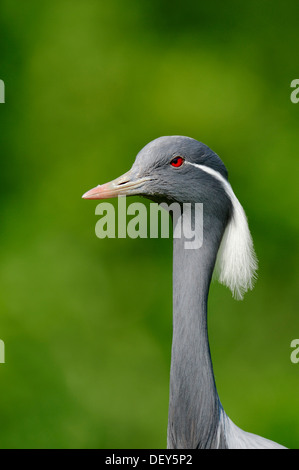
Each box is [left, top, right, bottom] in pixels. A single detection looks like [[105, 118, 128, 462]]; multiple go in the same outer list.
[[83, 136, 231, 221]]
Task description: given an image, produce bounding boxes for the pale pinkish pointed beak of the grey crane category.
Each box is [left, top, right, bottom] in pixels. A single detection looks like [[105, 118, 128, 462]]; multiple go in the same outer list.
[[82, 170, 149, 199]]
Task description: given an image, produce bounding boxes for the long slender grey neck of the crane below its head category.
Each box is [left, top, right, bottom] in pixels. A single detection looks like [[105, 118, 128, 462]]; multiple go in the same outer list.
[[167, 207, 226, 449]]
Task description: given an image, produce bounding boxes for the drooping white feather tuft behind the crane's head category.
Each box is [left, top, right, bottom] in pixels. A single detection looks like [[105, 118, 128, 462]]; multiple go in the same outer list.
[[215, 185, 258, 300]]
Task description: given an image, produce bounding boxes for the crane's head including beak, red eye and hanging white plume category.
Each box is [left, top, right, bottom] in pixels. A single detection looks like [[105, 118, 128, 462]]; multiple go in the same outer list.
[[83, 136, 257, 299]]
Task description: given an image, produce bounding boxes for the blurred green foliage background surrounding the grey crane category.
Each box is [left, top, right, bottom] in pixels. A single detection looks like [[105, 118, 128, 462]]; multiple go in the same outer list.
[[0, 0, 299, 448]]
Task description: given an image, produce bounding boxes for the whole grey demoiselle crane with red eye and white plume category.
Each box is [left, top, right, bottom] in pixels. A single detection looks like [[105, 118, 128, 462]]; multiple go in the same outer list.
[[83, 136, 283, 449]]
